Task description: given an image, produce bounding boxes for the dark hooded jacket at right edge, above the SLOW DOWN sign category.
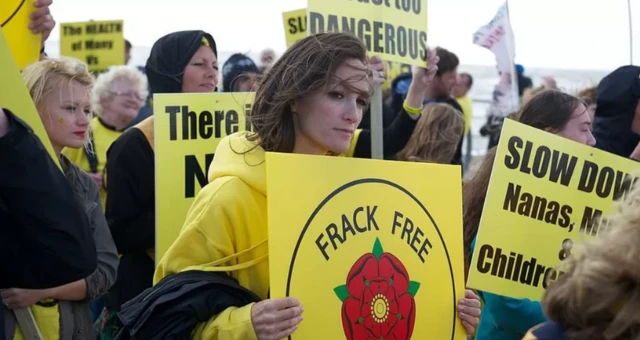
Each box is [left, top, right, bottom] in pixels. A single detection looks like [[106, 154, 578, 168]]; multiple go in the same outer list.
[[593, 66, 640, 158]]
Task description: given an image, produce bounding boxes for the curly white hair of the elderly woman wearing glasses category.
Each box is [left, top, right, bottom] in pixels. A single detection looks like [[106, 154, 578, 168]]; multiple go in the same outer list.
[[91, 66, 149, 116]]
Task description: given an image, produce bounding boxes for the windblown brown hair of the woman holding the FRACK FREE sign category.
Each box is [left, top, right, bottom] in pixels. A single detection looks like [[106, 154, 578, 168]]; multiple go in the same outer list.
[[247, 32, 373, 152]]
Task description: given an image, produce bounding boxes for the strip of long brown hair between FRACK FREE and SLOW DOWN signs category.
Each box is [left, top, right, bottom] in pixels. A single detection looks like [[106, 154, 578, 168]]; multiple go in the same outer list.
[[462, 147, 496, 280]]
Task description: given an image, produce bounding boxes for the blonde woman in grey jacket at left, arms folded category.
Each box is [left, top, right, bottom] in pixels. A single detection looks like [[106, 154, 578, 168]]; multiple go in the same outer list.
[[0, 58, 118, 340]]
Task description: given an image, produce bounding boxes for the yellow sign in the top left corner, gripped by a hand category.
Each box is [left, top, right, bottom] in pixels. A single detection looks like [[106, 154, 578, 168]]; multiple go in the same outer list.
[[0, 0, 42, 70]]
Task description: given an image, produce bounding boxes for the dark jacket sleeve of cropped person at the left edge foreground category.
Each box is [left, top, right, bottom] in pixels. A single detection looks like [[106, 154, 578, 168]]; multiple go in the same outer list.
[[0, 110, 97, 289]]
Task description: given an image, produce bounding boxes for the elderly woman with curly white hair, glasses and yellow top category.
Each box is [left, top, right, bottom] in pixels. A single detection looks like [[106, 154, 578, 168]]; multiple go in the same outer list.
[[63, 66, 148, 207]]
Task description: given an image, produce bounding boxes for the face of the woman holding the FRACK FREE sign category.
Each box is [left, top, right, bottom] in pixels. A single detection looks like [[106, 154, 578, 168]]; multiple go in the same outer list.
[[292, 59, 371, 155]]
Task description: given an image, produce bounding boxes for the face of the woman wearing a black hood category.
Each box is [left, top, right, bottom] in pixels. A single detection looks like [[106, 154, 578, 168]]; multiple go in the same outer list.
[[182, 45, 218, 93]]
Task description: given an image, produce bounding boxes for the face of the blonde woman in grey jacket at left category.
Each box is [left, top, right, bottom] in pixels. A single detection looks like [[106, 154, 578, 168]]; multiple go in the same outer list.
[[38, 80, 91, 154]]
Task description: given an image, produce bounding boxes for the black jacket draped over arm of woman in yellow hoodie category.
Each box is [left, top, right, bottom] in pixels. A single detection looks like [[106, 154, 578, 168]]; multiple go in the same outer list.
[[115, 270, 260, 340]]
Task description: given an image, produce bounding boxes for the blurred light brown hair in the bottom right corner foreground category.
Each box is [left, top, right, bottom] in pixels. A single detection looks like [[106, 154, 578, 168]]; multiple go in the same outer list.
[[542, 179, 640, 340]]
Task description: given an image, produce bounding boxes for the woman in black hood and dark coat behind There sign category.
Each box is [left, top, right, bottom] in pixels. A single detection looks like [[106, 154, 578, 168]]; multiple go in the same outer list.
[[99, 31, 219, 339]]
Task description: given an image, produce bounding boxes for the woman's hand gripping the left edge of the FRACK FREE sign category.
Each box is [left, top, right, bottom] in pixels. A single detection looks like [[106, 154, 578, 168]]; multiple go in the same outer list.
[[251, 297, 304, 340]]
